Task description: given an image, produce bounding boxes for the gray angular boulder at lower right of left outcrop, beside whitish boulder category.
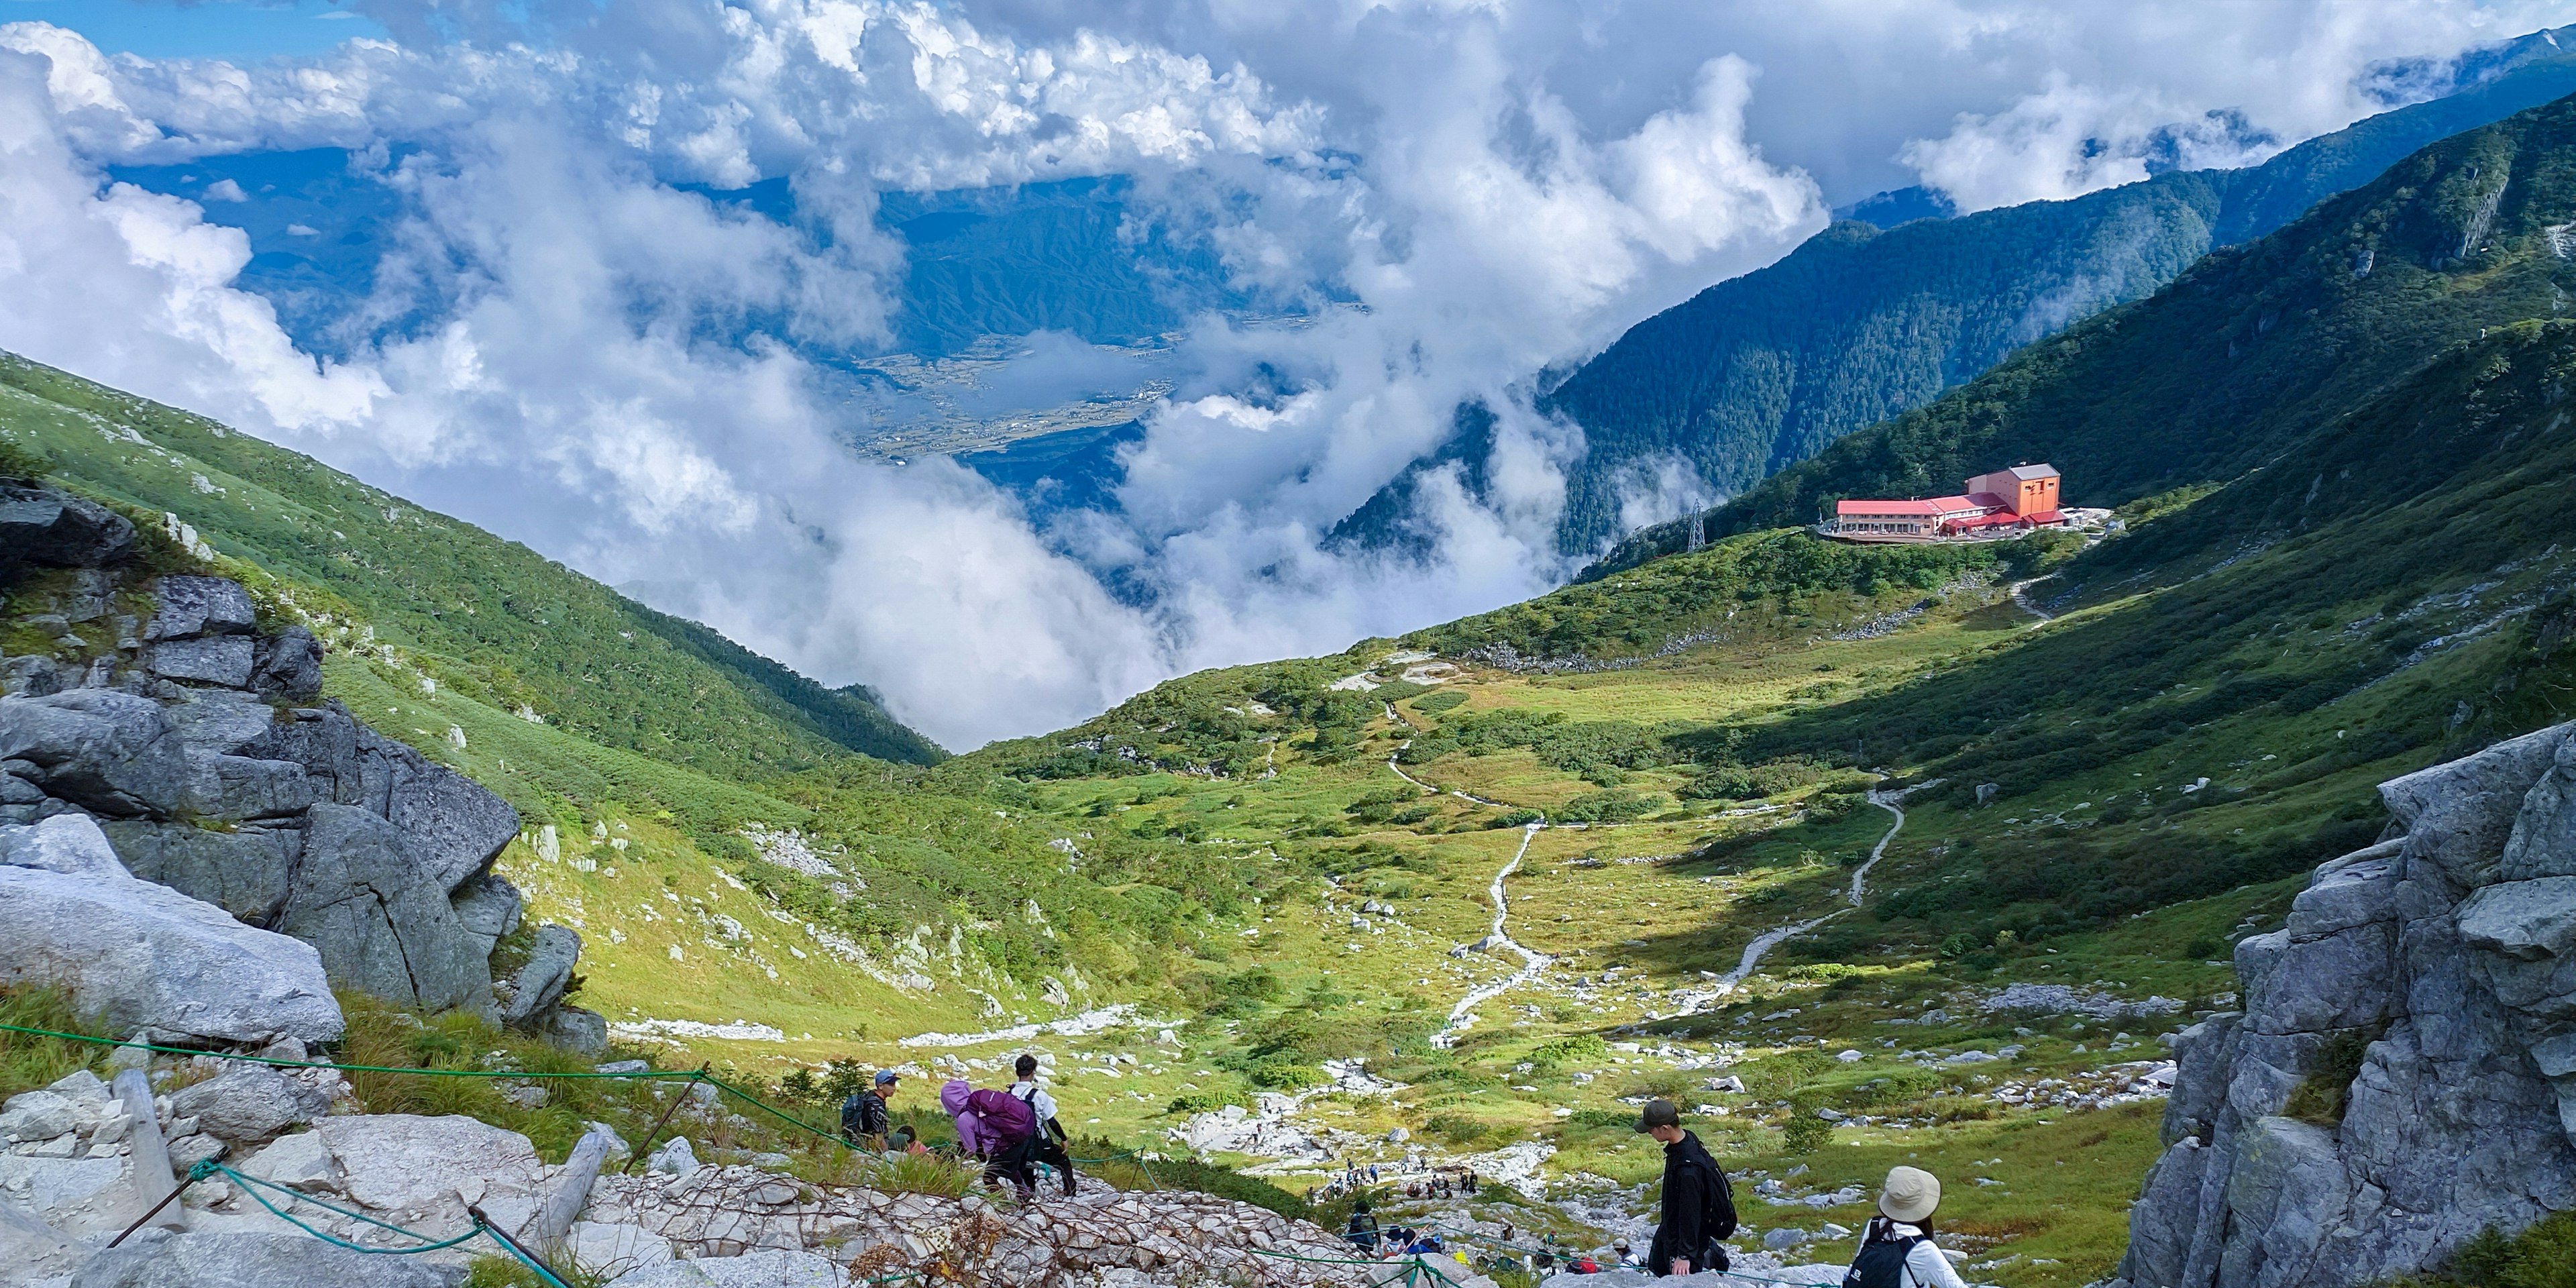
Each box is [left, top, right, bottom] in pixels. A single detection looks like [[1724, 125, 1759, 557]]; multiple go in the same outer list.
[[276, 804, 492, 1010]]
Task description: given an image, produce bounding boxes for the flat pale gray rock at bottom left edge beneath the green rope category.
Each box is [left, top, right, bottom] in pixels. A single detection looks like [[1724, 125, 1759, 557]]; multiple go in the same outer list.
[[70, 1232, 466, 1288]]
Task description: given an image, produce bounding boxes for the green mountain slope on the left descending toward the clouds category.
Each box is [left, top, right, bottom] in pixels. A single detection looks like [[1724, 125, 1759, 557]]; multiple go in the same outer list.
[[0, 356, 943, 775]]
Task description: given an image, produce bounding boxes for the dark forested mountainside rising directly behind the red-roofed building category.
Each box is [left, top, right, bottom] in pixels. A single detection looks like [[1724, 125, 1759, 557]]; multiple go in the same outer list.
[[1587, 84, 2576, 577]]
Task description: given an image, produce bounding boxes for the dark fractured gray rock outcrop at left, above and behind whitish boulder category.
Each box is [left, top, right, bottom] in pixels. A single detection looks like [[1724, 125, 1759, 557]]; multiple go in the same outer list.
[[0, 484, 605, 1049]]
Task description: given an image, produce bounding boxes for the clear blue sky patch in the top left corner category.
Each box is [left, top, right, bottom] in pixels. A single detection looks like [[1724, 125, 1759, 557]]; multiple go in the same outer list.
[[0, 0, 384, 62]]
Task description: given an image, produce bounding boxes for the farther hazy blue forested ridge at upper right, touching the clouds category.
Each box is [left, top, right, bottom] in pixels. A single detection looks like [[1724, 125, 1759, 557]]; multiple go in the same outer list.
[[1543, 46, 2576, 551]]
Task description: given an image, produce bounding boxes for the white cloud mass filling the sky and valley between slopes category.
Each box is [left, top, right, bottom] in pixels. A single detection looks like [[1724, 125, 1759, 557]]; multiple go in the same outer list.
[[0, 0, 2542, 747]]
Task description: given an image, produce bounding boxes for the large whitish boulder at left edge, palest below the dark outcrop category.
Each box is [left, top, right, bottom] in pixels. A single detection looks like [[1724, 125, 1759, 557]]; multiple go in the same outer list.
[[0, 814, 340, 1043]]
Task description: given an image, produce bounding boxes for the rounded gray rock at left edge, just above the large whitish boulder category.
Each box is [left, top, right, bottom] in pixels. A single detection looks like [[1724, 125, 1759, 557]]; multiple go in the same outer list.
[[0, 688, 191, 816]]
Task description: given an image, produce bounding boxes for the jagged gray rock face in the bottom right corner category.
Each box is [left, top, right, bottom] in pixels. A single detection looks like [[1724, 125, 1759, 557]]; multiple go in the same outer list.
[[2112, 724, 2576, 1288]]
